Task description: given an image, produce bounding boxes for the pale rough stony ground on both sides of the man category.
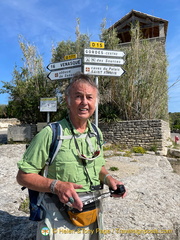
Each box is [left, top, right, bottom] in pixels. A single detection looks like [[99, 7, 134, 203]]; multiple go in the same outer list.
[[0, 144, 180, 240]]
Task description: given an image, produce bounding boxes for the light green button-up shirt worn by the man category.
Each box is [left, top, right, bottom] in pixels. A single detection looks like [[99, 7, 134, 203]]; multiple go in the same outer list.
[[18, 119, 105, 192]]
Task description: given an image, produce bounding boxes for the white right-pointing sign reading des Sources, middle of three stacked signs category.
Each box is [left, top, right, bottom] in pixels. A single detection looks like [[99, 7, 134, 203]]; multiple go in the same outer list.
[[84, 56, 125, 65]]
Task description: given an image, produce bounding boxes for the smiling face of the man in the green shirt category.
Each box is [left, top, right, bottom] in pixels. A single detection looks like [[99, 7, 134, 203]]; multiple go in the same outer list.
[[67, 82, 97, 120]]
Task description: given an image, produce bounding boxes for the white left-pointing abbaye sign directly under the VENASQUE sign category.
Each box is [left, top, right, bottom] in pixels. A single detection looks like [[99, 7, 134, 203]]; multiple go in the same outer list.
[[48, 67, 82, 80]]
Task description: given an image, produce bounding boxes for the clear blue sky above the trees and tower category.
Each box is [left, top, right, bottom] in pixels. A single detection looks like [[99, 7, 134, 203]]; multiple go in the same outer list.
[[0, 0, 180, 112]]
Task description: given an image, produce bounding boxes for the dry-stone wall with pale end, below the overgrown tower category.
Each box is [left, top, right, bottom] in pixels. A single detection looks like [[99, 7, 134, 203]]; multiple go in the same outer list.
[[99, 120, 170, 152]]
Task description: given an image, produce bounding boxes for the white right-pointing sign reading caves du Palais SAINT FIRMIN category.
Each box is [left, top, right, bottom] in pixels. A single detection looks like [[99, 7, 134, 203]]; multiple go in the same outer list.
[[84, 64, 124, 77]]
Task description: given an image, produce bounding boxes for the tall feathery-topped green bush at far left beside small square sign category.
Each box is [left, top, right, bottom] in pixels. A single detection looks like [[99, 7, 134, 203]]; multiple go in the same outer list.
[[0, 37, 58, 123]]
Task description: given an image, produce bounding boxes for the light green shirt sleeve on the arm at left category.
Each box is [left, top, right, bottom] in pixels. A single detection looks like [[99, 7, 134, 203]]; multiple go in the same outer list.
[[17, 126, 52, 173]]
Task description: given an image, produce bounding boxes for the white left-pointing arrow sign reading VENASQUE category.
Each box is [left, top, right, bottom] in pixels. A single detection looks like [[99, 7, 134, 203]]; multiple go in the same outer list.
[[47, 58, 82, 71]]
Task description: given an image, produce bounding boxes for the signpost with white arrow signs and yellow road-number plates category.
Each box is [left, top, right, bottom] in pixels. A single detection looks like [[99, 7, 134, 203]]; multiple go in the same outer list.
[[47, 45, 125, 126]]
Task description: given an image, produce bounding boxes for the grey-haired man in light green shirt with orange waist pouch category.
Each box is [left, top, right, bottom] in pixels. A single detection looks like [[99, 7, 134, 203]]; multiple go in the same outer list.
[[17, 74, 125, 240]]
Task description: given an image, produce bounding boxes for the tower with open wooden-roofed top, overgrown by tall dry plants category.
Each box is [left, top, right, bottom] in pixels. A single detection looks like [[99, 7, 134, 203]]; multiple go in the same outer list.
[[103, 10, 168, 121]]
